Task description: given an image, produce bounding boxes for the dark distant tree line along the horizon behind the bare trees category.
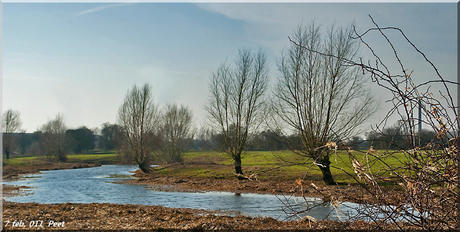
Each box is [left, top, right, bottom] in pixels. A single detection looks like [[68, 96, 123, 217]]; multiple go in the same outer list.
[[3, 112, 436, 161]]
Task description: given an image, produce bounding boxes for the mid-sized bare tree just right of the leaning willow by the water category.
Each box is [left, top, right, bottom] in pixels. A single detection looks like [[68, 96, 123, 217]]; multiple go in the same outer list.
[[162, 104, 193, 163]]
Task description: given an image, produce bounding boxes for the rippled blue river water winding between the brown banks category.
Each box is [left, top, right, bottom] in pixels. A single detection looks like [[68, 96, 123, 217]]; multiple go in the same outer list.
[[5, 165, 353, 220]]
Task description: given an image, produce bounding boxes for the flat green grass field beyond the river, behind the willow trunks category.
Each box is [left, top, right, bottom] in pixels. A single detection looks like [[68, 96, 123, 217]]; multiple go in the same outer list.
[[3, 151, 406, 183]]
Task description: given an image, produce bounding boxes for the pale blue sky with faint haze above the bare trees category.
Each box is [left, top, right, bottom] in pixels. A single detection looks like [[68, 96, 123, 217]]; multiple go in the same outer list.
[[1, 2, 457, 136]]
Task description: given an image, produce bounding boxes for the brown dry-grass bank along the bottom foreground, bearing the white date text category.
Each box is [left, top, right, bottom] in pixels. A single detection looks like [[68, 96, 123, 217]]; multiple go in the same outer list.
[[3, 202, 414, 231]]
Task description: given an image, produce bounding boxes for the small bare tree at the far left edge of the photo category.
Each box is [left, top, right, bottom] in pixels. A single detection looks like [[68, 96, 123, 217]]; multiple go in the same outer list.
[[2, 109, 22, 159]]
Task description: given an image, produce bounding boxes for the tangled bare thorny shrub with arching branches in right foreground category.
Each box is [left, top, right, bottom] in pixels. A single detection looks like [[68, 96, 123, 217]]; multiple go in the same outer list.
[[282, 17, 460, 231]]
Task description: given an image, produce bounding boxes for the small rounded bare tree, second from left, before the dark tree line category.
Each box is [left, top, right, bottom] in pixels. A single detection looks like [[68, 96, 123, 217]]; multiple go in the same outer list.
[[40, 114, 71, 161]]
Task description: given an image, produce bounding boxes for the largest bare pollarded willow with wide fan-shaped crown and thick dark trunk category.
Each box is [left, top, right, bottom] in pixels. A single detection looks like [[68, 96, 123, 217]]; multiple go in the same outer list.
[[272, 22, 378, 185]]
